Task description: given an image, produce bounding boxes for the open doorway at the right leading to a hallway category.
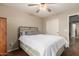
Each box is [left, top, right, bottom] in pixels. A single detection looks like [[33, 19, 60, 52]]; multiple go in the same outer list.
[[69, 15, 79, 46]]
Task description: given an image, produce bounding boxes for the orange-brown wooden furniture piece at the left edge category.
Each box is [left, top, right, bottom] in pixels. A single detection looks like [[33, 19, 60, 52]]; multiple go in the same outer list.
[[0, 17, 7, 55]]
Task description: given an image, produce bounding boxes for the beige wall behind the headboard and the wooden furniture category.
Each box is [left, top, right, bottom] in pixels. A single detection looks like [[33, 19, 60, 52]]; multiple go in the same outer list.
[[0, 5, 42, 50]]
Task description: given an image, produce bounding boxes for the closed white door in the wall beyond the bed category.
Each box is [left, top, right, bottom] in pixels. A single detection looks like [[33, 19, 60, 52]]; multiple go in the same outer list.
[[46, 19, 59, 35]]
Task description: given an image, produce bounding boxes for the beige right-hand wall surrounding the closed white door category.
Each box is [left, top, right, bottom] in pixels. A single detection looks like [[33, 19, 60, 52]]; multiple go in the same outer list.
[[43, 8, 79, 42]]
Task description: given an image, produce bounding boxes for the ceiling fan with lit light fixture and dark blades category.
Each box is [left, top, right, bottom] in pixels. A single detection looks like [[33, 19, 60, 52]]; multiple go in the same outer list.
[[28, 3, 55, 13]]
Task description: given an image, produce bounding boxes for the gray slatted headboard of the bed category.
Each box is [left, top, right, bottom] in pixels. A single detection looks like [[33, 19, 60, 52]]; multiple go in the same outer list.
[[18, 26, 39, 36]]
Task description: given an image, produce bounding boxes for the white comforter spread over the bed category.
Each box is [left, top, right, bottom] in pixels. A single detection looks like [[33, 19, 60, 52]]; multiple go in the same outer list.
[[19, 34, 66, 56]]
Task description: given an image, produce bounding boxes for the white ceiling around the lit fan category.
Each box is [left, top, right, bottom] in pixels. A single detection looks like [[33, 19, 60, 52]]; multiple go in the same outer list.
[[1, 3, 79, 17]]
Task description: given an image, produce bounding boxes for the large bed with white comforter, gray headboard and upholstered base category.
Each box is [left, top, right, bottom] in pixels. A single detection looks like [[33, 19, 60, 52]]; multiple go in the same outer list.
[[19, 26, 66, 56]]
